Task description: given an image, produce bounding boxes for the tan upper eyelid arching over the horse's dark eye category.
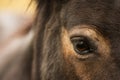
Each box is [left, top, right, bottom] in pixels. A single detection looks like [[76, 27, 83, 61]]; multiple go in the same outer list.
[[68, 25, 101, 41]]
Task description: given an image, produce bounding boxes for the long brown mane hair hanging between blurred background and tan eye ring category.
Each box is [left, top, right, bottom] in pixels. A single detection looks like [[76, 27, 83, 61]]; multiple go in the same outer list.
[[33, 0, 71, 80]]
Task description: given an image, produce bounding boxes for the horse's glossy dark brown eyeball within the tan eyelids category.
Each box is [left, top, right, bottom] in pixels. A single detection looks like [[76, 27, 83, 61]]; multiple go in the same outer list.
[[71, 37, 94, 55]]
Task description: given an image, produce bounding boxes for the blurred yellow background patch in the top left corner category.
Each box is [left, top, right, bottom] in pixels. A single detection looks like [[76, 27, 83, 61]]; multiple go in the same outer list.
[[0, 0, 36, 15]]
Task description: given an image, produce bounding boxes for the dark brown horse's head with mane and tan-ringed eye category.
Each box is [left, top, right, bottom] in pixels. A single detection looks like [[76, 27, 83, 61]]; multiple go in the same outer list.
[[32, 0, 120, 80]]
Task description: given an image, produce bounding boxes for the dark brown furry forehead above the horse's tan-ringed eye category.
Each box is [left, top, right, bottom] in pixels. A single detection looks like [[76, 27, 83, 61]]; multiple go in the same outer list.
[[62, 0, 120, 36]]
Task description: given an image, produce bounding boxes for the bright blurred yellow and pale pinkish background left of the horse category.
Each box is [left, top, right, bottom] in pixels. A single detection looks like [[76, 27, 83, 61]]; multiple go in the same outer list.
[[0, 0, 36, 80]]
